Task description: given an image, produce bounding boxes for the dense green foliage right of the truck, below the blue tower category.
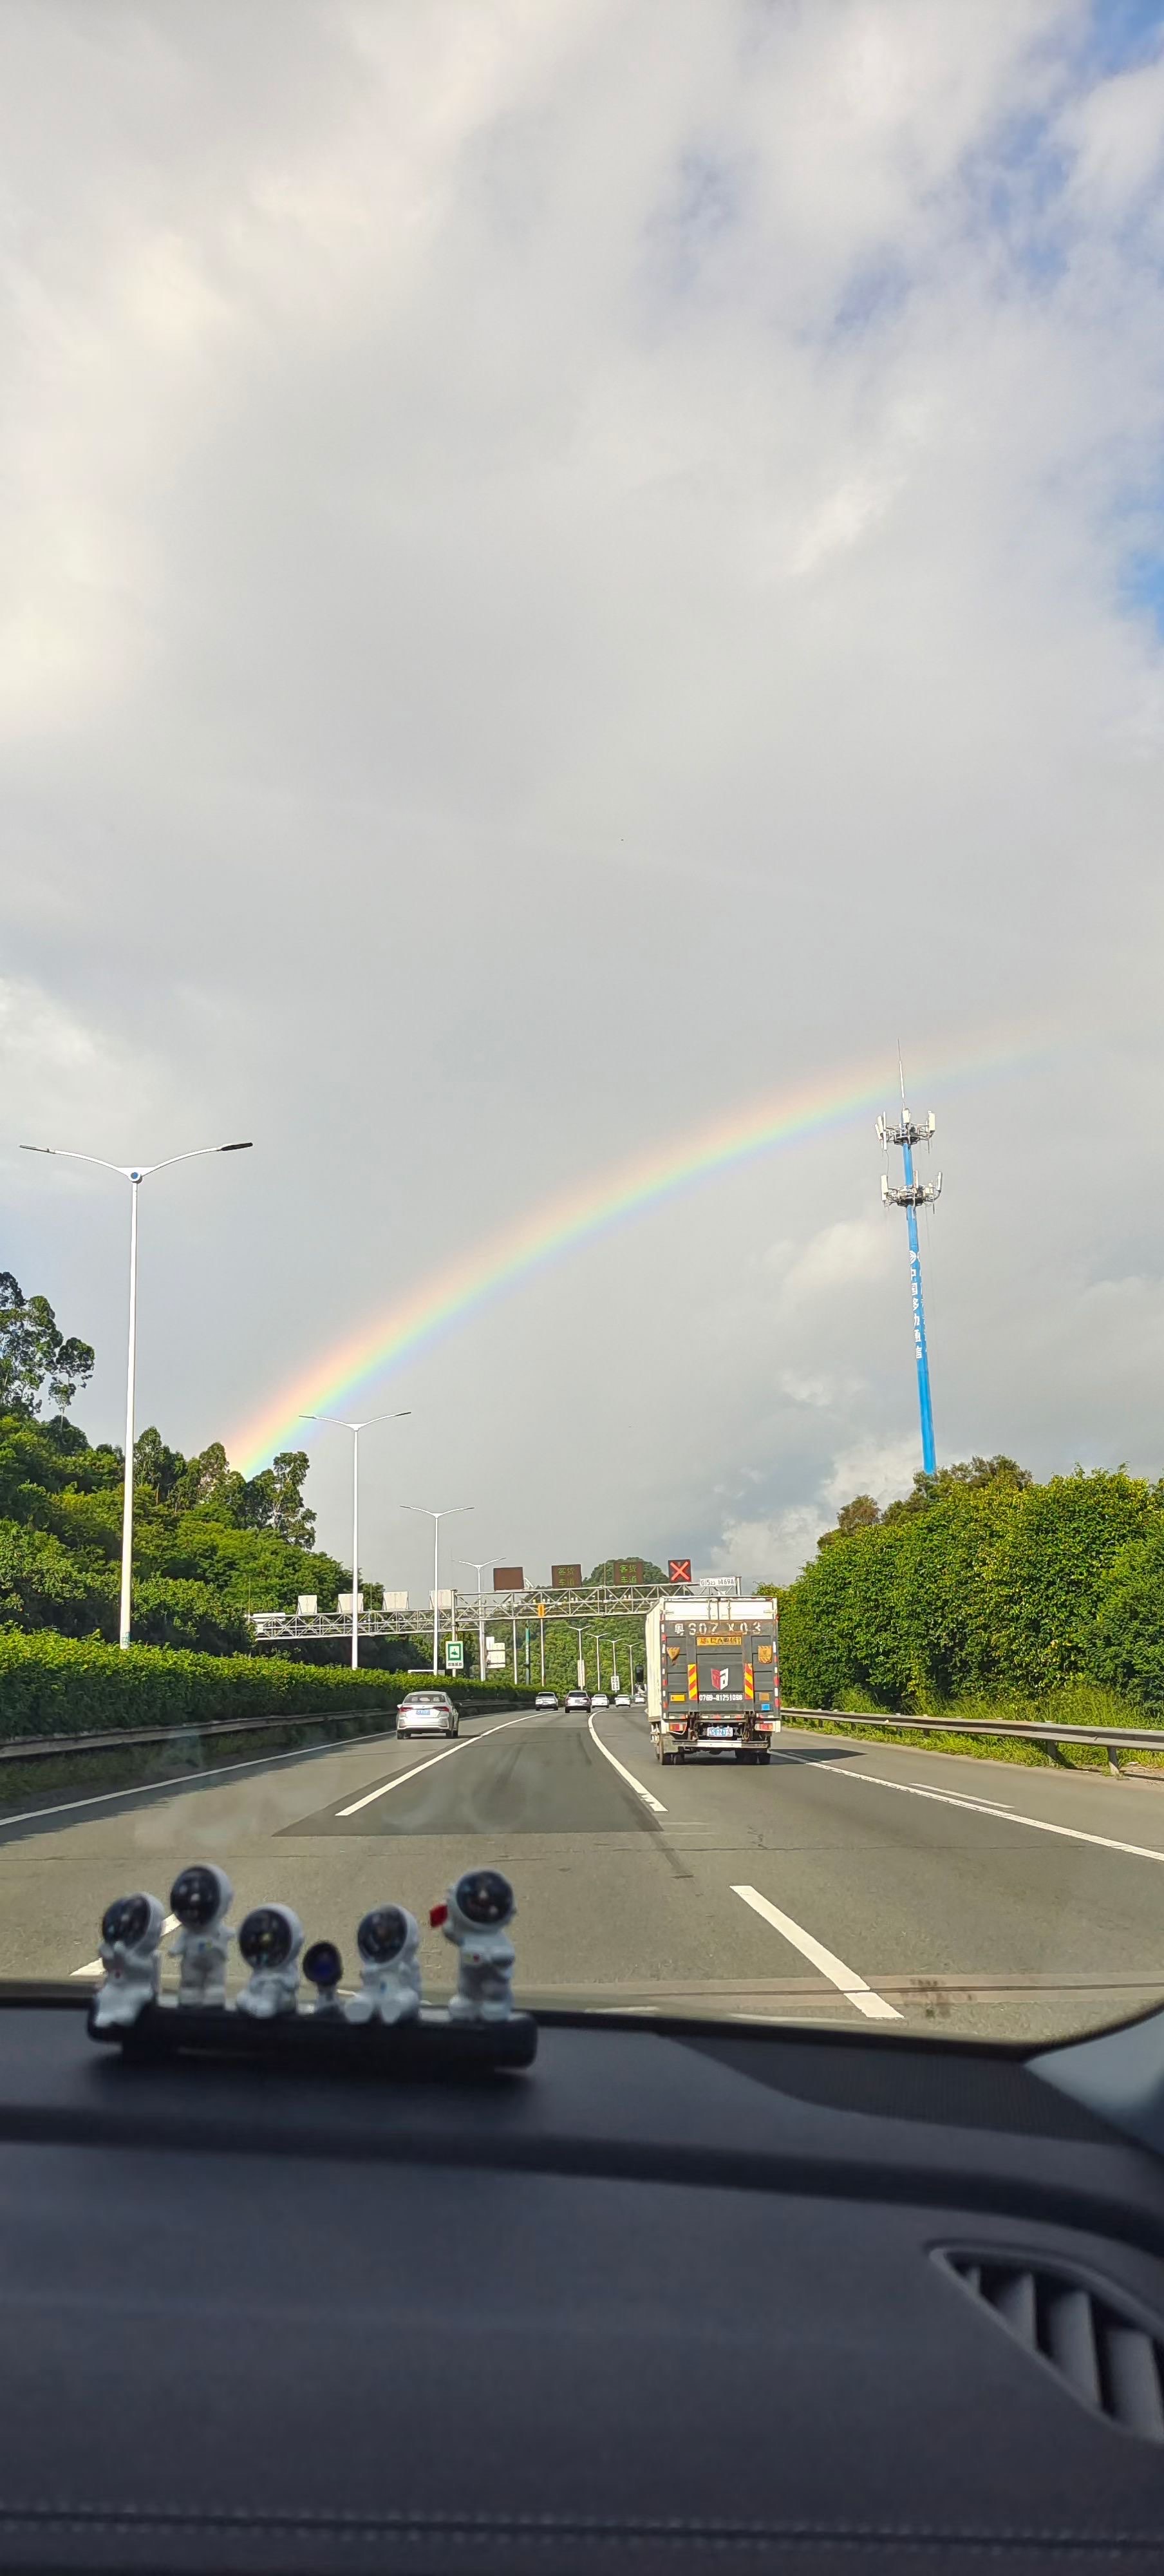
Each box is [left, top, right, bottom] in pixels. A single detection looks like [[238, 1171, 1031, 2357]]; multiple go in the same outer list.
[[780, 1458, 1164, 1710]]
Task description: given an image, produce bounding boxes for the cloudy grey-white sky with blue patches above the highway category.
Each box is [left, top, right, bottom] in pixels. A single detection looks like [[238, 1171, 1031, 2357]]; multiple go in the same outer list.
[[0, 0, 1164, 1600]]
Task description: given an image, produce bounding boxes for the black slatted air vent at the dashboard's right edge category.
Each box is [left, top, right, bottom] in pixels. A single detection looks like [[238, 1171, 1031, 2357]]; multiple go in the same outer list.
[[937, 2249, 1164, 2442]]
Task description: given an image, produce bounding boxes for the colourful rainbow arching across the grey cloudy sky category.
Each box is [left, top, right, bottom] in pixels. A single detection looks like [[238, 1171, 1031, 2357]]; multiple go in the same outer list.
[[227, 1038, 1038, 1476]]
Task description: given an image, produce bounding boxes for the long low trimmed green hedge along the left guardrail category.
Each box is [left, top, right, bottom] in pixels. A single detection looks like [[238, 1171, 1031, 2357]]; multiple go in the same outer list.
[[0, 1628, 533, 1741]]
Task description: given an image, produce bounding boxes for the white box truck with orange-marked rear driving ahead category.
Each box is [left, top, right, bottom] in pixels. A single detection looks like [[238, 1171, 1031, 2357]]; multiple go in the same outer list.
[[646, 1592, 780, 1762]]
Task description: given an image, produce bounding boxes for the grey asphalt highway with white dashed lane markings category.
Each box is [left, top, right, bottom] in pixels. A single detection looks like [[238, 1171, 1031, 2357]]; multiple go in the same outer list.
[[0, 1708, 1164, 2038]]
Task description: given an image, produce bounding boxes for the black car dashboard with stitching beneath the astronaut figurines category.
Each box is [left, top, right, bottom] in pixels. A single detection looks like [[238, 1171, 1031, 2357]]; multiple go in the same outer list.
[[0, 1989, 1164, 2576]]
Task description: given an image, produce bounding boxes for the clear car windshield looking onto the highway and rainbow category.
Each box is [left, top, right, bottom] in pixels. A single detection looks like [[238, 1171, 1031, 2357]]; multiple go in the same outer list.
[[0, 0, 1164, 2040]]
